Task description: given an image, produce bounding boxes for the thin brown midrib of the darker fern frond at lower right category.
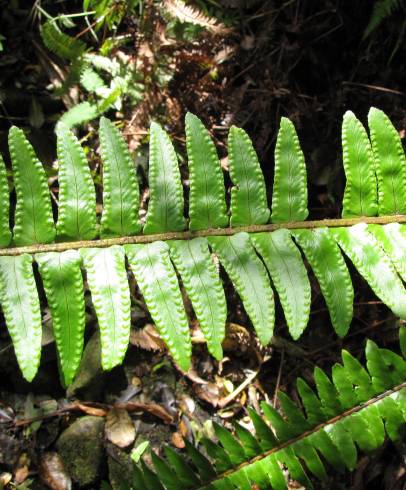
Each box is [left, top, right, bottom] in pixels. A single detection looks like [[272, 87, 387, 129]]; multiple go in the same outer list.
[[202, 381, 406, 490]]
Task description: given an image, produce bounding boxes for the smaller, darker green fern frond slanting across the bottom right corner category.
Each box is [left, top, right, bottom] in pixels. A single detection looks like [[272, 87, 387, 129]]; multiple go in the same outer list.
[[132, 332, 406, 490]]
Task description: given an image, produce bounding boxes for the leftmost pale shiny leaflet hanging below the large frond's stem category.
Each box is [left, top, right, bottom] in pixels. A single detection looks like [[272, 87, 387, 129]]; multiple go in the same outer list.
[[0, 254, 42, 381]]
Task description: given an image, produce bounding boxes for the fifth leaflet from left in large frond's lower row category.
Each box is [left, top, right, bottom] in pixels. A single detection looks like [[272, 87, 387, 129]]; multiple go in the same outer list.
[[169, 238, 227, 360]]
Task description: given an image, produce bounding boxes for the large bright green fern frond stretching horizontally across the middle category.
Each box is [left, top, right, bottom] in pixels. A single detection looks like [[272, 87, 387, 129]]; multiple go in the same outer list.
[[0, 109, 406, 384]]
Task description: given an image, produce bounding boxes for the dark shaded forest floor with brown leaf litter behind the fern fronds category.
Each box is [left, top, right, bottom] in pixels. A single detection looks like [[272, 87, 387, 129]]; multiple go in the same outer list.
[[0, 0, 406, 490]]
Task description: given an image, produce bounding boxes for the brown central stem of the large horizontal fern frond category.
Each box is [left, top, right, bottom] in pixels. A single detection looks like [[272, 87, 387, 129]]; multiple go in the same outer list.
[[0, 215, 406, 257]]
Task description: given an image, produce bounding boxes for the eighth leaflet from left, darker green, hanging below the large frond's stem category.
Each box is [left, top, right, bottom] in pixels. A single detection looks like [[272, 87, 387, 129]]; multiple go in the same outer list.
[[292, 228, 354, 337]]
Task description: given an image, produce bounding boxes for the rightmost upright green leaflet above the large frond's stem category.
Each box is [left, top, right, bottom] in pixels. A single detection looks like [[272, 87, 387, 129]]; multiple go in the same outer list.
[[368, 107, 406, 216]]
